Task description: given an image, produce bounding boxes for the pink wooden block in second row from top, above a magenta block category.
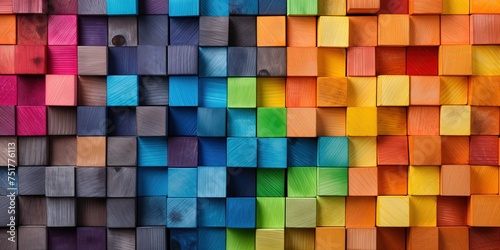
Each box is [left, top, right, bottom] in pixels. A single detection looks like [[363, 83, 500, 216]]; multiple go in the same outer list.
[[48, 15, 78, 45]]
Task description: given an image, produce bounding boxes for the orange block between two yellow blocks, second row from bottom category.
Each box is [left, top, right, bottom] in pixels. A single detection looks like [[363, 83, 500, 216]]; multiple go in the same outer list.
[[345, 196, 376, 228]]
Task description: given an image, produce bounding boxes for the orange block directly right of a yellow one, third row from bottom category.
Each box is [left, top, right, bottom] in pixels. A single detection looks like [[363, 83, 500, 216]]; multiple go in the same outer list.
[[439, 165, 471, 196]]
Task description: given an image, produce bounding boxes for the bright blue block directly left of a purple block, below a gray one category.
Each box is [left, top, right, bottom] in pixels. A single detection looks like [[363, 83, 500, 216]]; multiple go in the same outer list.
[[138, 137, 167, 167]]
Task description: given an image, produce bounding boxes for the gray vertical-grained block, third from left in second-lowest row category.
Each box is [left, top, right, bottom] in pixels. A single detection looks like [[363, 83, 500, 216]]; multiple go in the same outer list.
[[47, 198, 76, 227]]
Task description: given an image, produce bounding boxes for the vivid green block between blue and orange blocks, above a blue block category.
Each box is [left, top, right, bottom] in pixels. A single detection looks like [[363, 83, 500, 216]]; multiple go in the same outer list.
[[257, 108, 286, 137]]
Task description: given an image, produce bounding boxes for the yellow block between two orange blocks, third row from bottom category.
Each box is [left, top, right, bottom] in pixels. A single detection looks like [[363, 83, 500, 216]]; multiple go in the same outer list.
[[408, 166, 439, 195]]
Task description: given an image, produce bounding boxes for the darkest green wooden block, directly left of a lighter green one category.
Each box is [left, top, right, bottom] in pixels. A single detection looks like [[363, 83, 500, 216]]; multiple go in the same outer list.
[[257, 168, 285, 197]]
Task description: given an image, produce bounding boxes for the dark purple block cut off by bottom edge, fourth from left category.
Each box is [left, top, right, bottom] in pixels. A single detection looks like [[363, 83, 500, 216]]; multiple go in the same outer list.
[[76, 227, 106, 250]]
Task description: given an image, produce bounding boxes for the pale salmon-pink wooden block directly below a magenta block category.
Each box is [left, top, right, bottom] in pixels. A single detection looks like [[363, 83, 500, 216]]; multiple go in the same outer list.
[[45, 75, 76, 106]]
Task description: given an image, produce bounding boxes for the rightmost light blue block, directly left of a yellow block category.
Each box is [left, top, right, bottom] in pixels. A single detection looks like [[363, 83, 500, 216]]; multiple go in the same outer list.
[[318, 137, 349, 167]]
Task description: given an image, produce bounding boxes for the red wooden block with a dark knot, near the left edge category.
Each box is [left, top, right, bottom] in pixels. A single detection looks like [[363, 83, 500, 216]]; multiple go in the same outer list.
[[15, 45, 47, 74]]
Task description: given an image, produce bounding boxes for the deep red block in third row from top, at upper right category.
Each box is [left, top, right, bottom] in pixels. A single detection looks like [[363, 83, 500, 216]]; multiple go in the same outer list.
[[407, 47, 438, 75]]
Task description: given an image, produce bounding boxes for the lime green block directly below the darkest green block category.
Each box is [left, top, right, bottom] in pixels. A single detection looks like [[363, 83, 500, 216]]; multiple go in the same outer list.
[[257, 197, 285, 229]]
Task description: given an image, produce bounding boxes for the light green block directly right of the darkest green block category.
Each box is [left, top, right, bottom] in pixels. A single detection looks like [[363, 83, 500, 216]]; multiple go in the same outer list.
[[288, 167, 316, 197]]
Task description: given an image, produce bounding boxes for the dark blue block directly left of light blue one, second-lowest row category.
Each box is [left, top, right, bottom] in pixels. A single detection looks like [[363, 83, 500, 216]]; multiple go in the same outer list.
[[137, 196, 167, 226]]
